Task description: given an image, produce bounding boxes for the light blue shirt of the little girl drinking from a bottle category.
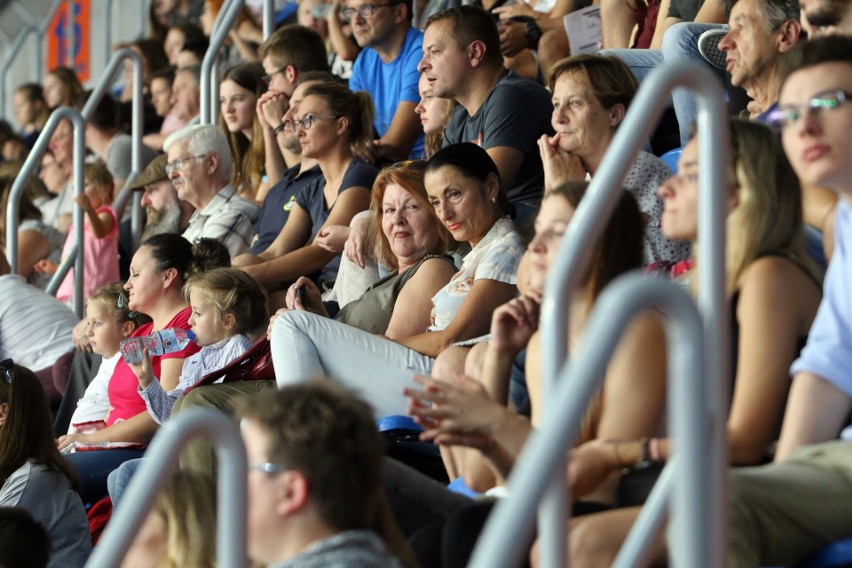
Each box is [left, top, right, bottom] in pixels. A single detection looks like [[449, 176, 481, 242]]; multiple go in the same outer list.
[[138, 334, 251, 424]]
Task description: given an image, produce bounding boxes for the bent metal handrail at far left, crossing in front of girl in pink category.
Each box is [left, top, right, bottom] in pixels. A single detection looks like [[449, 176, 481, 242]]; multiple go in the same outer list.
[[6, 107, 86, 317]]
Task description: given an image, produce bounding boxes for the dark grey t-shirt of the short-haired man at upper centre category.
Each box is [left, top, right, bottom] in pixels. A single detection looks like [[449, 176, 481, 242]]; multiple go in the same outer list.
[[444, 71, 553, 203]]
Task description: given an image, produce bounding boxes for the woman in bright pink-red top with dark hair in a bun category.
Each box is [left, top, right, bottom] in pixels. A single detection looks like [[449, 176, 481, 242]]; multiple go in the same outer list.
[[57, 233, 228, 503]]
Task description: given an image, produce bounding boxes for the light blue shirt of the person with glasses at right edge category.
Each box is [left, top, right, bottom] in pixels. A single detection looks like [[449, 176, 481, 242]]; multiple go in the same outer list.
[[790, 198, 852, 398]]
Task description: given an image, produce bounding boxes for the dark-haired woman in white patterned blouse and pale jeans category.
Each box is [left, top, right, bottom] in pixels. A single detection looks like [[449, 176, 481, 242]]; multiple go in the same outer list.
[[271, 142, 522, 416]]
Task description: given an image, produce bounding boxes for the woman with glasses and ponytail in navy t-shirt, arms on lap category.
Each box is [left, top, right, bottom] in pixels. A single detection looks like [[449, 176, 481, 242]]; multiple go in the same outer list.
[[233, 82, 378, 308]]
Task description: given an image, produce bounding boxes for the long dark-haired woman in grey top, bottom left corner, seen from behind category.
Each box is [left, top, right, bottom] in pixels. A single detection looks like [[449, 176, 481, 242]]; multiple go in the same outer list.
[[0, 359, 92, 568]]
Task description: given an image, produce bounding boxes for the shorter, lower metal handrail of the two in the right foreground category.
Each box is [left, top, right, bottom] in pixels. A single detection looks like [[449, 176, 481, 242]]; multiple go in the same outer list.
[[471, 274, 708, 568]]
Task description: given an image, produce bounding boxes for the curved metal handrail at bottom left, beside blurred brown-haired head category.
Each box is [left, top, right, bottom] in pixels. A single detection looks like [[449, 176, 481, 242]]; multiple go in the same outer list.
[[86, 409, 247, 568]]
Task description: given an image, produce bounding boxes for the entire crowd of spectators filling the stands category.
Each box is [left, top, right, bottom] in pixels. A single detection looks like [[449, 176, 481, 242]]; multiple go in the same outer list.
[[0, 0, 852, 567]]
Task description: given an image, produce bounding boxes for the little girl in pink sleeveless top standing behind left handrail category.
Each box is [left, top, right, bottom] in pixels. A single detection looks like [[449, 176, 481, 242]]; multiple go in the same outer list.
[[53, 162, 119, 303]]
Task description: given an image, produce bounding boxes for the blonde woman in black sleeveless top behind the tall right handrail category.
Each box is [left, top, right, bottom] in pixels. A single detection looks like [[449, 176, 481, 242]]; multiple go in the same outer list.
[[569, 120, 822, 566]]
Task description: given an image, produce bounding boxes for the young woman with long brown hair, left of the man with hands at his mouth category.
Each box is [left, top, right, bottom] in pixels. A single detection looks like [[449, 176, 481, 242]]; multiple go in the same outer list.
[[219, 62, 267, 203]]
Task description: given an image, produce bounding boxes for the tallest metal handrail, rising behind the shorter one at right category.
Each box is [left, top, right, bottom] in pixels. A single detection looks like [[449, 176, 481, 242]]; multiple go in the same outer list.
[[528, 62, 728, 566]]
